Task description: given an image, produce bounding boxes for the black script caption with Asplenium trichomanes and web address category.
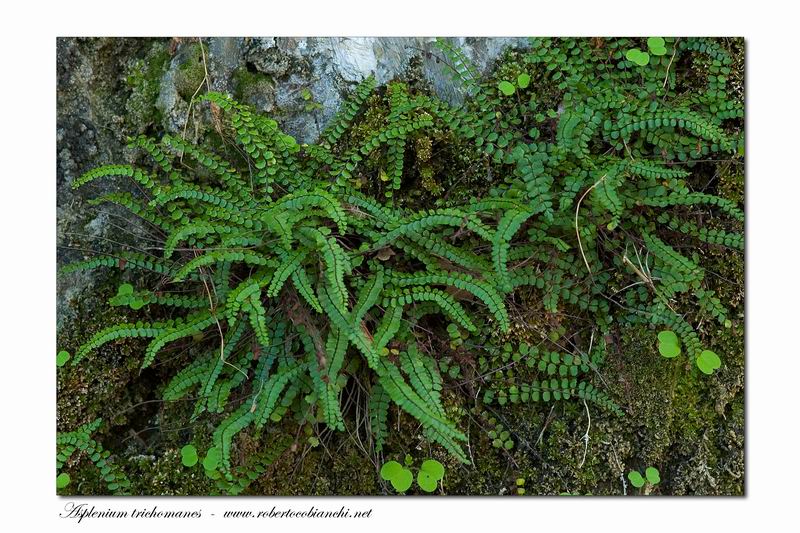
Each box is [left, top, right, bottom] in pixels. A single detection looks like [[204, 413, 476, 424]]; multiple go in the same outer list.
[[59, 502, 372, 523]]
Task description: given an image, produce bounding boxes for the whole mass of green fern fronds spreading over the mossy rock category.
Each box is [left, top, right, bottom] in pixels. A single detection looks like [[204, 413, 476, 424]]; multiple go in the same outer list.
[[62, 38, 744, 474]]
